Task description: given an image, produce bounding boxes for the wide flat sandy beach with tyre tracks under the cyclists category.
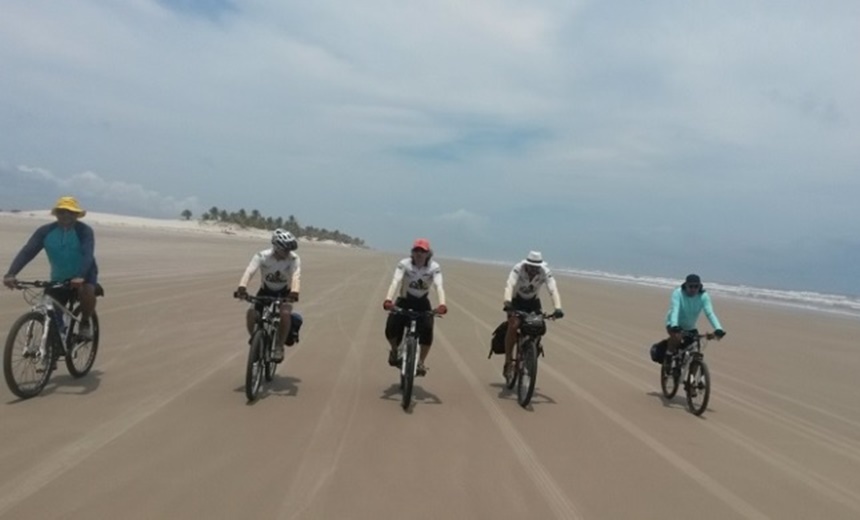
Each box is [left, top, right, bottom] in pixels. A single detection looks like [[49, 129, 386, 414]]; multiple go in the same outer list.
[[5, 213, 860, 520]]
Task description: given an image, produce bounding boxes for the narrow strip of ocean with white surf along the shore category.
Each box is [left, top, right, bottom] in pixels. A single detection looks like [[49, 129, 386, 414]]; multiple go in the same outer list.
[[461, 258, 860, 318]]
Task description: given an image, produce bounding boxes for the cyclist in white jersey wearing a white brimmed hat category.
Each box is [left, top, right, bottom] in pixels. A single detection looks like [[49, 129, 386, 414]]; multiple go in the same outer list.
[[502, 251, 564, 376]]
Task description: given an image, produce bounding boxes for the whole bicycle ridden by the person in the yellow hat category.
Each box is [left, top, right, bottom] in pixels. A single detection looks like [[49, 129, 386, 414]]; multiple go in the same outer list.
[[3, 280, 104, 399]]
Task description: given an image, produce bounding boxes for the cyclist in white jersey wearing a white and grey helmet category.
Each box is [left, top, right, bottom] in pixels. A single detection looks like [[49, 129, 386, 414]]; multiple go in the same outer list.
[[236, 229, 301, 361]]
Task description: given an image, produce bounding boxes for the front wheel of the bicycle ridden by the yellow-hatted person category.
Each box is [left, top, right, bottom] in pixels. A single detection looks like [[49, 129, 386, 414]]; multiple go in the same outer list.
[[3, 312, 53, 399]]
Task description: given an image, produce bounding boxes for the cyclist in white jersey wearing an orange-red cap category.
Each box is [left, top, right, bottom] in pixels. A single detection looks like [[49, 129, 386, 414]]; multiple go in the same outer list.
[[382, 238, 448, 376]]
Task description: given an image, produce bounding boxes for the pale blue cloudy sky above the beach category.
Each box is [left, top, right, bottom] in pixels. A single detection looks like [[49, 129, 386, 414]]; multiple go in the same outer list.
[[0, 0, 860, 295]]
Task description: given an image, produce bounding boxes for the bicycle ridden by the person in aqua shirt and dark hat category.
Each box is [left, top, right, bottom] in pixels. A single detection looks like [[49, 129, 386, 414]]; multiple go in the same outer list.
[[660, 331, 716, 416]]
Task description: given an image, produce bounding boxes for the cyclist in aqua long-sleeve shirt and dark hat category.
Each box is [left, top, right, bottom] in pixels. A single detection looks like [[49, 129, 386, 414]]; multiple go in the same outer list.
[[651, 274, 726, 363]]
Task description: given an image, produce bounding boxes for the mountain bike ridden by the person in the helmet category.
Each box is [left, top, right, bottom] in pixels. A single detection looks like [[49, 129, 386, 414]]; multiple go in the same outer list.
[[233, 293, 292, 401]]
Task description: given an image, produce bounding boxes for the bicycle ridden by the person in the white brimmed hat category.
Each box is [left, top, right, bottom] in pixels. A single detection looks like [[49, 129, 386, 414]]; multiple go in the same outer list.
[[505, 310, 555, 408]]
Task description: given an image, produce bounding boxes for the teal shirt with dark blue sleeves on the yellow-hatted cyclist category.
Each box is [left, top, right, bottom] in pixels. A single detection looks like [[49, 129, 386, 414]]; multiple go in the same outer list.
[[7, 222, 98, 283]]
